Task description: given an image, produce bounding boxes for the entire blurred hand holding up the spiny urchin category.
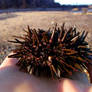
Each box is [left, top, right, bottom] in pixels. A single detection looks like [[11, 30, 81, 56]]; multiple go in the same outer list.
[[0, 53, 92, 92]]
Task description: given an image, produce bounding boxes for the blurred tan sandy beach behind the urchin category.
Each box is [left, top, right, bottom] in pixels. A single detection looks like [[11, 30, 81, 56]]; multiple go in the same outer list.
[[0, 8, 92, 62]]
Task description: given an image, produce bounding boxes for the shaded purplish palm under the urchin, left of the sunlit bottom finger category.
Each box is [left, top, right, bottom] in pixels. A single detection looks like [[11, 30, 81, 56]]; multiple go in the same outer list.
[[0, 58, 57, 92]]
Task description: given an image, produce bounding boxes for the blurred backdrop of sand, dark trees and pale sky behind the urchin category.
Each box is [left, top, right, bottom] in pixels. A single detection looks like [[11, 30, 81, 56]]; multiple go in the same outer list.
[[0, 0, 92, 63]]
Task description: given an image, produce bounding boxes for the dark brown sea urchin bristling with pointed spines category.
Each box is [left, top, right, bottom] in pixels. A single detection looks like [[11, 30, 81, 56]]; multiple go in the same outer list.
[[9, 24, 92, 82]]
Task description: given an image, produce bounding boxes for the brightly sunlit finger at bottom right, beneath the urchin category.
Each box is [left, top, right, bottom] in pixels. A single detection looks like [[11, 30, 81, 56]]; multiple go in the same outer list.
[[59, 79, 89, 92]]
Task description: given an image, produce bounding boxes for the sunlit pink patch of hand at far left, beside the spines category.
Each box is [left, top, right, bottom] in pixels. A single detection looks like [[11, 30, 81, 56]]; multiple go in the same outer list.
[[0, 53, 18, 67]]
